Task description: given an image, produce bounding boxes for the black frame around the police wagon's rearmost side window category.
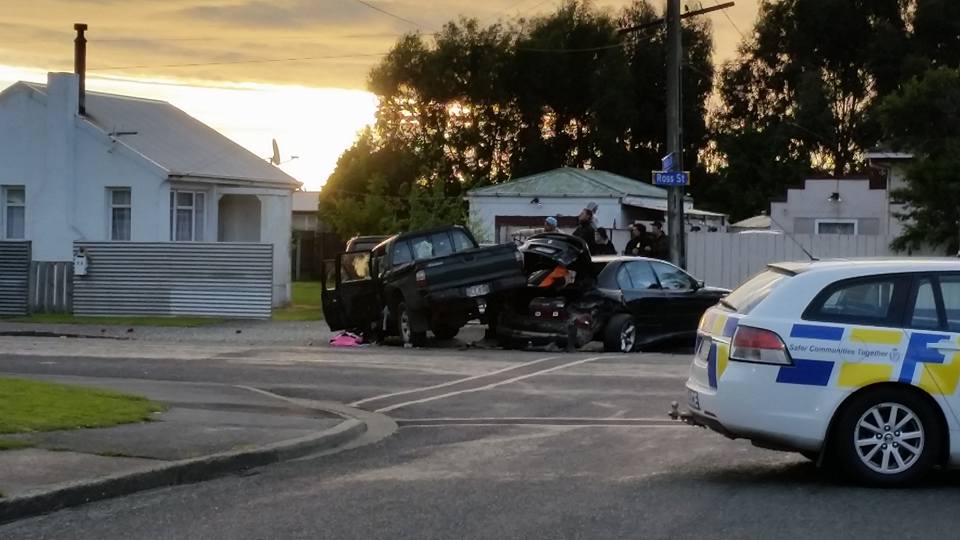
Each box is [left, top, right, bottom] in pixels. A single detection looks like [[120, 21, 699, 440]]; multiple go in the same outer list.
[[800, 273, 912, 328]]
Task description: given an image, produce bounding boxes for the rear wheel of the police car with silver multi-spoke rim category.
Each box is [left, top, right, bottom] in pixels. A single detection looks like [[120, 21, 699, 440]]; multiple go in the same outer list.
[[834, 388, 943, 486]]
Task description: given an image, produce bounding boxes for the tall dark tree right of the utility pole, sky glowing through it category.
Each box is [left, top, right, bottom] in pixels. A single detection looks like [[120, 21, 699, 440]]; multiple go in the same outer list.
[[712, 0, 908, 221]]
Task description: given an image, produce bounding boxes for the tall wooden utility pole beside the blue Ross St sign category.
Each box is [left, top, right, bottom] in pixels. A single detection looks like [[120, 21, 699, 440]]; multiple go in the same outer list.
[[667, 0, 687, 268]]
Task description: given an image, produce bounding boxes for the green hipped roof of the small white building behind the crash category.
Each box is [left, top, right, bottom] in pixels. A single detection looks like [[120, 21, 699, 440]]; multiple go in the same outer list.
[[467, 167, 667, 199]]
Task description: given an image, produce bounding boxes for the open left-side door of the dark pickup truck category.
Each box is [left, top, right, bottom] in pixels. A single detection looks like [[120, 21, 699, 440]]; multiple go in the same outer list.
[[322, 251, 381, 331]]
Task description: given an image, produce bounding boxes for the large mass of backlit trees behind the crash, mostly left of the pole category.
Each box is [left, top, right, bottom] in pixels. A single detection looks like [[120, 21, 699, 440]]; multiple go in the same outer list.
[[321, 0, 713, 235]]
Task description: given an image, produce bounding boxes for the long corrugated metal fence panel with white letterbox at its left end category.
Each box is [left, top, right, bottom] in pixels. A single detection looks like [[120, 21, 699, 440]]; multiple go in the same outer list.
[[73, 242, 273, 319]]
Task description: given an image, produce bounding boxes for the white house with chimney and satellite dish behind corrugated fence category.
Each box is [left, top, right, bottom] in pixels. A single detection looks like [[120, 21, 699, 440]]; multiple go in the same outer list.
[[0, 73, 300, 305]]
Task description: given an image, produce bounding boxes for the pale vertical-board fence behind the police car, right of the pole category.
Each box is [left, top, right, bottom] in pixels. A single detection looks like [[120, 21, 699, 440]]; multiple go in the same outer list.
[[687, 232, 943, 288]]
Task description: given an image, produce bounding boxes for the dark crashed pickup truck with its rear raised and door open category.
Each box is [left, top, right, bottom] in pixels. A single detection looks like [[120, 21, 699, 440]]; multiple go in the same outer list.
[[323, 226, 527, 346]]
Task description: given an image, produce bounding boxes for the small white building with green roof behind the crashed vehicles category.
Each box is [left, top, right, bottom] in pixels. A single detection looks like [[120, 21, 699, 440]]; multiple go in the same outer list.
[[466, 167, 726, 246]]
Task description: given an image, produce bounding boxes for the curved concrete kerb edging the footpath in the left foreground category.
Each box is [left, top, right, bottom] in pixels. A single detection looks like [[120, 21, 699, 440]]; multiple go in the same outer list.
[[0, 413, 367, 523]]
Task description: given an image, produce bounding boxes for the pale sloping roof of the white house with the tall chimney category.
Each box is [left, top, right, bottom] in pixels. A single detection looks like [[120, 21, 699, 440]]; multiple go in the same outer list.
[[18, 82, 300, 188]]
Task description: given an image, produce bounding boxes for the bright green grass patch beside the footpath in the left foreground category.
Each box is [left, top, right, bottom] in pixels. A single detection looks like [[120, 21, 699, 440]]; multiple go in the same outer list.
[[0, 379, 163, 436]]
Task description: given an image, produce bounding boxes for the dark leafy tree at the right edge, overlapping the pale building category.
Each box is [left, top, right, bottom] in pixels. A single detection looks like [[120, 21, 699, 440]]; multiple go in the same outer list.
[[878, 68, 960, 253]]
